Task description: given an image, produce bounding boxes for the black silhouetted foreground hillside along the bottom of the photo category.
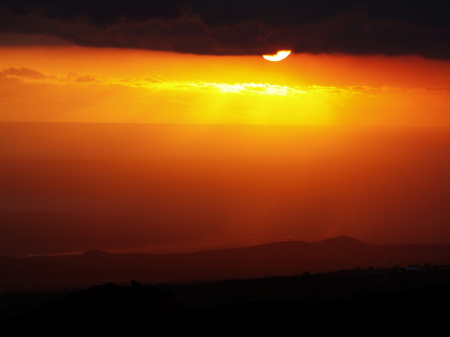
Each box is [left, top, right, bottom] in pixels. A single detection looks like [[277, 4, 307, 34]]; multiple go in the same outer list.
[[2, 269, 450, 336]]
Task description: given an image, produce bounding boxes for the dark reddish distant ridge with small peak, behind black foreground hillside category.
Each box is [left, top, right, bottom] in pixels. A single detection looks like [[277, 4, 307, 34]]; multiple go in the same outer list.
[[0, 236, 450, 284]]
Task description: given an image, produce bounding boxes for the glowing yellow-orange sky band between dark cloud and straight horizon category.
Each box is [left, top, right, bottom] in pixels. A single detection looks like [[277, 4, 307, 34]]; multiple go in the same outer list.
[[0, 47, 450, 125]]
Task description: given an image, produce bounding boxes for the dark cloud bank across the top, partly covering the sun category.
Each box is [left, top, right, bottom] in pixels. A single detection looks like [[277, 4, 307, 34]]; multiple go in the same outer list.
[[0, 0, 450, 59]]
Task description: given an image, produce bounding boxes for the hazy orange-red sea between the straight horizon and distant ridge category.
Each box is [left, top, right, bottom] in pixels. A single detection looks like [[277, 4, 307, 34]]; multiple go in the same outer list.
[[0, 123, 450, 255]]
